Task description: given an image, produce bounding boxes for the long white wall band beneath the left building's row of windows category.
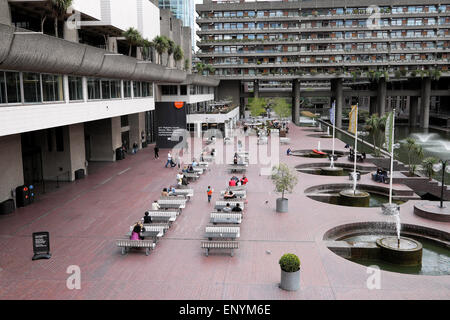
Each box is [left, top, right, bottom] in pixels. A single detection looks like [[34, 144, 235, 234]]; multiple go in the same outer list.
[[0, 97, 155, 136]]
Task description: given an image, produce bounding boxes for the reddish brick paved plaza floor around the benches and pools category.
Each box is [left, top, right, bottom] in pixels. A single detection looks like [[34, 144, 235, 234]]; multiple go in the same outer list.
[[0, 126, 450, 300]]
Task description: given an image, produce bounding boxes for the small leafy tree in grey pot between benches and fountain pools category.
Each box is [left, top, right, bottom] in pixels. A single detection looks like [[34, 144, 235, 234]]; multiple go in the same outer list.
[[271, 163, 298, 213]]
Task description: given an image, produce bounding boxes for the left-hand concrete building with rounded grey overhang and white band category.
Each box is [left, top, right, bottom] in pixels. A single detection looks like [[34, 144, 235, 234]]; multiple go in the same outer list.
[[0, 0, 219, 211]]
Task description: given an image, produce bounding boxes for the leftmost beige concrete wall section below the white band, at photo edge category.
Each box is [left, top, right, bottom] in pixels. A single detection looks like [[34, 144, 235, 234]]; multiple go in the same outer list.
[[0, 134, 24, 202]]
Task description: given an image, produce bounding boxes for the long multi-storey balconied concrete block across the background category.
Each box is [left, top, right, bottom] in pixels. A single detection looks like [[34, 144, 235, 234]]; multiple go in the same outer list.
[[196, 0, 450, 128]]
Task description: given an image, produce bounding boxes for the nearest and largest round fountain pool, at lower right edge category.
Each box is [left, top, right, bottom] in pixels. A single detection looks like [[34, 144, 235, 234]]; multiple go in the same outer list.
[[324, 222, 450, 276]]
